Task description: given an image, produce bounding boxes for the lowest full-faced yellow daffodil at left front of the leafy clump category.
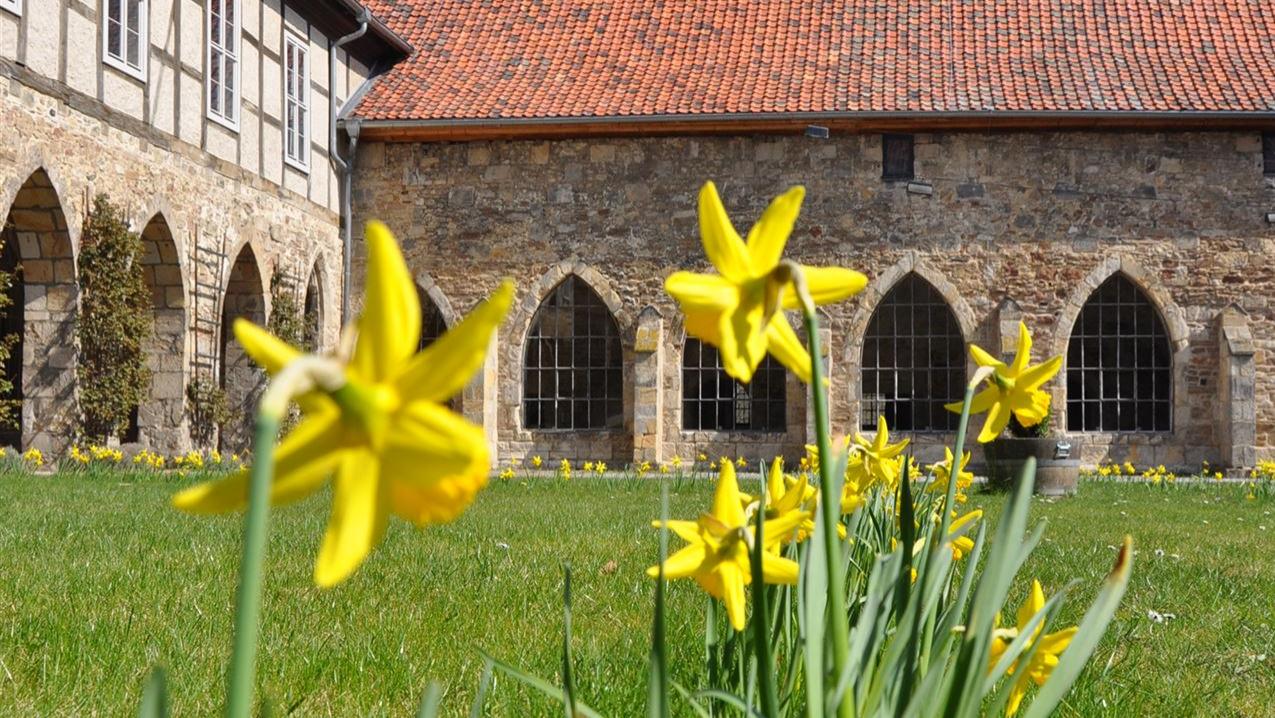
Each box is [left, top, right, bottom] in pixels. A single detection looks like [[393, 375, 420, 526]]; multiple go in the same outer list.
[[646, 462, 801, 631]]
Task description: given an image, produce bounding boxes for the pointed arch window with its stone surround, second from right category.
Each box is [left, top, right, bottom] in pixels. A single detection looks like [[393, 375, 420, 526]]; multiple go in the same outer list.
[[844, 258, 977, 432]]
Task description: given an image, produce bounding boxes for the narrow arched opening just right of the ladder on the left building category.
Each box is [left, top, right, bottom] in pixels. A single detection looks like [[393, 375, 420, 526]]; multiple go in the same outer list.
[[218, 242, 269, 451]]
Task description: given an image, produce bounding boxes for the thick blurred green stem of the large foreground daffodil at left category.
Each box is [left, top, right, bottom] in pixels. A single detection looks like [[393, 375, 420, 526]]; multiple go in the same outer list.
[[226, 410, 286, 718]]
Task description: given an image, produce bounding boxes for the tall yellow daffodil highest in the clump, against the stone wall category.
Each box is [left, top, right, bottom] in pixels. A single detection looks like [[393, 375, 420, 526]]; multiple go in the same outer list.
[[664, 182, 867, 384]]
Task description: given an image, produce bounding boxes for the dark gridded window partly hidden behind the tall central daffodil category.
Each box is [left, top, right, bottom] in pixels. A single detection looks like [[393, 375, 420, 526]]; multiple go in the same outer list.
[[682, 337, 788, 431]]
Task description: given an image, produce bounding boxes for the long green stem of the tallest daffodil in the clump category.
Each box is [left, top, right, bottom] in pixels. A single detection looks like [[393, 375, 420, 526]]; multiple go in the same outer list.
[[785, 263, 854, 718]]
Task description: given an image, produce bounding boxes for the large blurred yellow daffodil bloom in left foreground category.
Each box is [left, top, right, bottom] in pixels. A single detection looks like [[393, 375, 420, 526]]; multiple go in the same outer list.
[[173, 222, 514, 587]]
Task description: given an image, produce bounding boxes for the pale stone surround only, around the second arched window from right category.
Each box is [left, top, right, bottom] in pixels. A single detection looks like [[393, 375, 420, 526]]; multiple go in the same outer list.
[[842, 251, 978, 436]]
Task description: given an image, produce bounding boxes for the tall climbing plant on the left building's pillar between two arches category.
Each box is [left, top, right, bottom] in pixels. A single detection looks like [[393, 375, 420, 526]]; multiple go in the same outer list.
[[75, 195, 154, 439]]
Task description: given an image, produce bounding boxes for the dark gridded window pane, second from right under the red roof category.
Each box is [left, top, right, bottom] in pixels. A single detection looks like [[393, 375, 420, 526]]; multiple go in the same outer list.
[[859, 274, 965, 432]]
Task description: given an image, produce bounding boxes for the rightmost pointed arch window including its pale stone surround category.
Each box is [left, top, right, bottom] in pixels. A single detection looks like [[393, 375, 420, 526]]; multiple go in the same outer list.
[[1052, 256, 1190, 434]]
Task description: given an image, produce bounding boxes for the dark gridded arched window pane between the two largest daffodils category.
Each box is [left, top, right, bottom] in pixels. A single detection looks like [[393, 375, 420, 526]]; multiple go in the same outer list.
[[523, 275, 623, 429]]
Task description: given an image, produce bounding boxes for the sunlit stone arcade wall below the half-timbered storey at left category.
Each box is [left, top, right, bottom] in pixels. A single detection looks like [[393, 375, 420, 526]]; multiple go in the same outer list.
[[0, 74, 342, 450]]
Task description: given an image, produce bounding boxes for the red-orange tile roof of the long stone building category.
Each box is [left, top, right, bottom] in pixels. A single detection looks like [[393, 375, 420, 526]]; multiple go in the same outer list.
[[356, 0, 1275, 121]]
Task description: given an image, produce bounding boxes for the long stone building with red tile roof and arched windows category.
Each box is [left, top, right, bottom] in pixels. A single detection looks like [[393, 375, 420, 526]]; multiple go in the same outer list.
[[344, 0, 1275, 467]]
